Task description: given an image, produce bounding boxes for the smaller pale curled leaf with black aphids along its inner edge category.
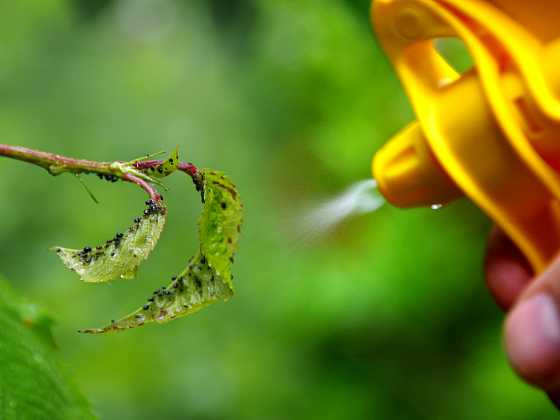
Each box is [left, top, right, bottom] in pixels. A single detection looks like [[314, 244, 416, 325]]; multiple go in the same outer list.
[[51, 200, 167, 283]]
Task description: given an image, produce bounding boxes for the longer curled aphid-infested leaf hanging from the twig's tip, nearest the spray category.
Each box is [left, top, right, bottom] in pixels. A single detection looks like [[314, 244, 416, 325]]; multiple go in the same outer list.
[[80, 169, 243, 334]]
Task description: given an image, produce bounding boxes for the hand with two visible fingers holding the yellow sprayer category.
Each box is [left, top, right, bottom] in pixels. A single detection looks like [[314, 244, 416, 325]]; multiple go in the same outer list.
[[485, 229, 560, 408]]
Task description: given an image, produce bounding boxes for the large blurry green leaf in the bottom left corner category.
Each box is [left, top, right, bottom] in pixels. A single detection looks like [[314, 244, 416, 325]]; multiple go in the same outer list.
[[0, 279, 96, 420]]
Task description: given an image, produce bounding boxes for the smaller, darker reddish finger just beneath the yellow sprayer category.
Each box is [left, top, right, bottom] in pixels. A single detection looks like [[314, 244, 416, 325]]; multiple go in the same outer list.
[[484, 228, 532, 310]]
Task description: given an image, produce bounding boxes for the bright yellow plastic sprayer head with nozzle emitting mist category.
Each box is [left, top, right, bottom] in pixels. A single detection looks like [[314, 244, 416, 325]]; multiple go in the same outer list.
[[372, 0, 560, 272]]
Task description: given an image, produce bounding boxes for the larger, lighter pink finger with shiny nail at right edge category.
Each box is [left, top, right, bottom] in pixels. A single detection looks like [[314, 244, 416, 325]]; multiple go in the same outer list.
[[505, 259, 560, 388]]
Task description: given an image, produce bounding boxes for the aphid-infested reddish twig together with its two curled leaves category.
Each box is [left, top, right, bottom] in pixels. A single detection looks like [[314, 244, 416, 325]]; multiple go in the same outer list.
[[0, 144, 243, 334]]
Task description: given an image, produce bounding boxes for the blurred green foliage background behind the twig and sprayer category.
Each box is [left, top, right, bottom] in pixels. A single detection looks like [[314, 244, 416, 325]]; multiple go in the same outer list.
[[0, 0, 556, 420]]
